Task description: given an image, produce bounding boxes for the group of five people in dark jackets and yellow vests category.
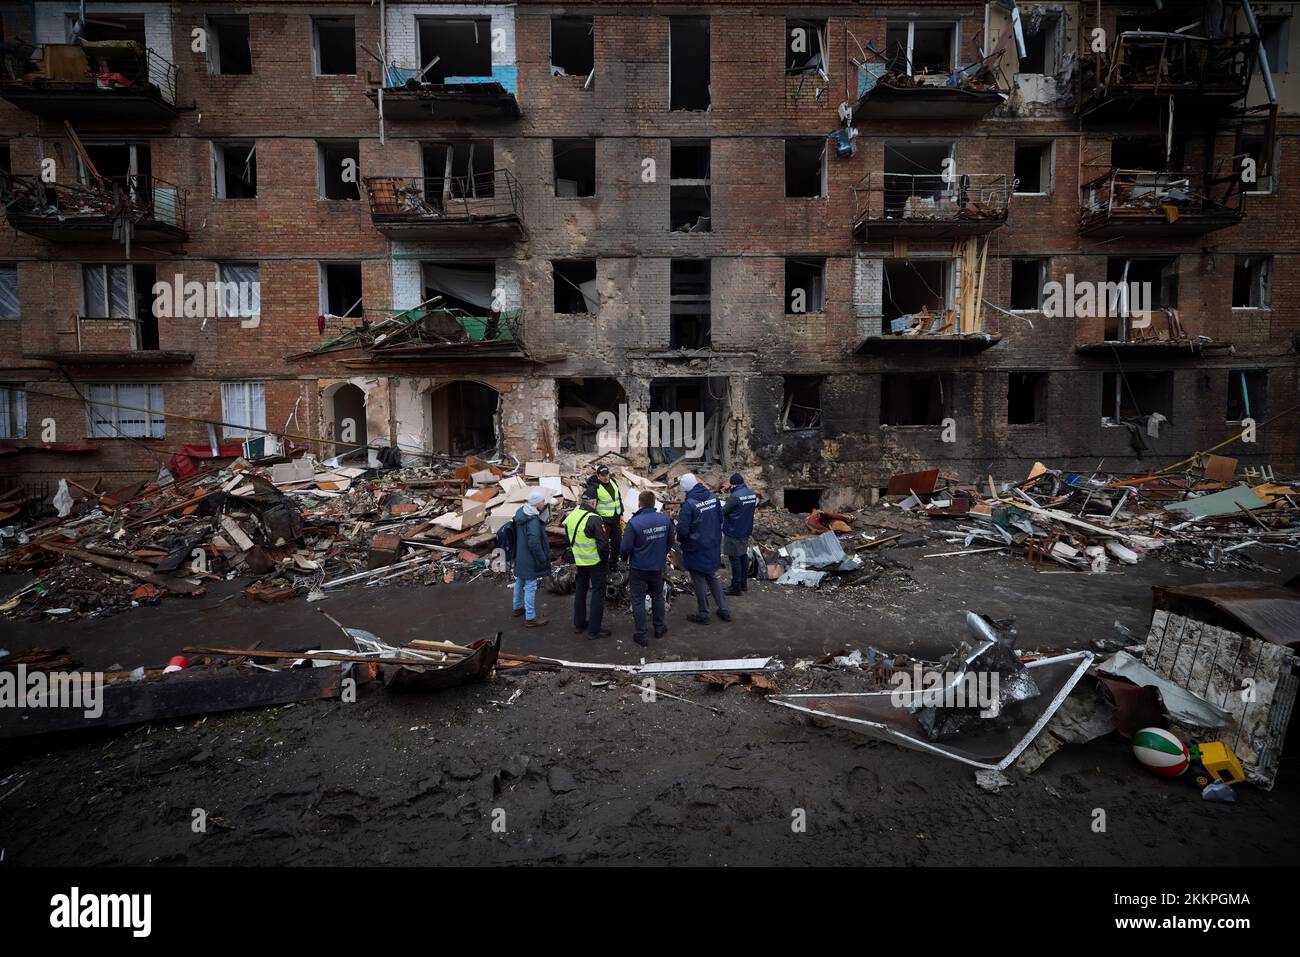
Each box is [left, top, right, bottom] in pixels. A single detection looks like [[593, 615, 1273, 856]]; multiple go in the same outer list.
[[501, 465, 758, 648]]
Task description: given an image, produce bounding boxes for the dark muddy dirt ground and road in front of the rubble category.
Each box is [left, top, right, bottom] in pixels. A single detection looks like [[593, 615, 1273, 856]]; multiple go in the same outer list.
[[0, 530, 1300, 866]]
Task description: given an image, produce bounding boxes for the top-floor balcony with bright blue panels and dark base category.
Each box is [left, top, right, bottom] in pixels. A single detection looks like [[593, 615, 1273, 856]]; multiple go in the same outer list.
[[365, 66, 519, 121]]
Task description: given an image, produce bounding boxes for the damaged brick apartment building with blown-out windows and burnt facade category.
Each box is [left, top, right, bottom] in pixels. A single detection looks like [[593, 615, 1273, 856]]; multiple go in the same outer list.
[[0, 0, 1300, 508]]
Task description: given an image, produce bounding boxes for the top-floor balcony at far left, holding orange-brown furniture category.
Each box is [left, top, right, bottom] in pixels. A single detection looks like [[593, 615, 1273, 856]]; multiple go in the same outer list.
[[0, 40, 178, 124]]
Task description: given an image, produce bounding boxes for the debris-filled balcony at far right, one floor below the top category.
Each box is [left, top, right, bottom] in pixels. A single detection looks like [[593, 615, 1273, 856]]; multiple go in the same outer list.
[[1079, 169, 1244, 239]]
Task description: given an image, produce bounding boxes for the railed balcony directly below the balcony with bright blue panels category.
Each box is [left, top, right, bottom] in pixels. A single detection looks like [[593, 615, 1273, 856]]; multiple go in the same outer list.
[[365, 169, 525, 242]]
